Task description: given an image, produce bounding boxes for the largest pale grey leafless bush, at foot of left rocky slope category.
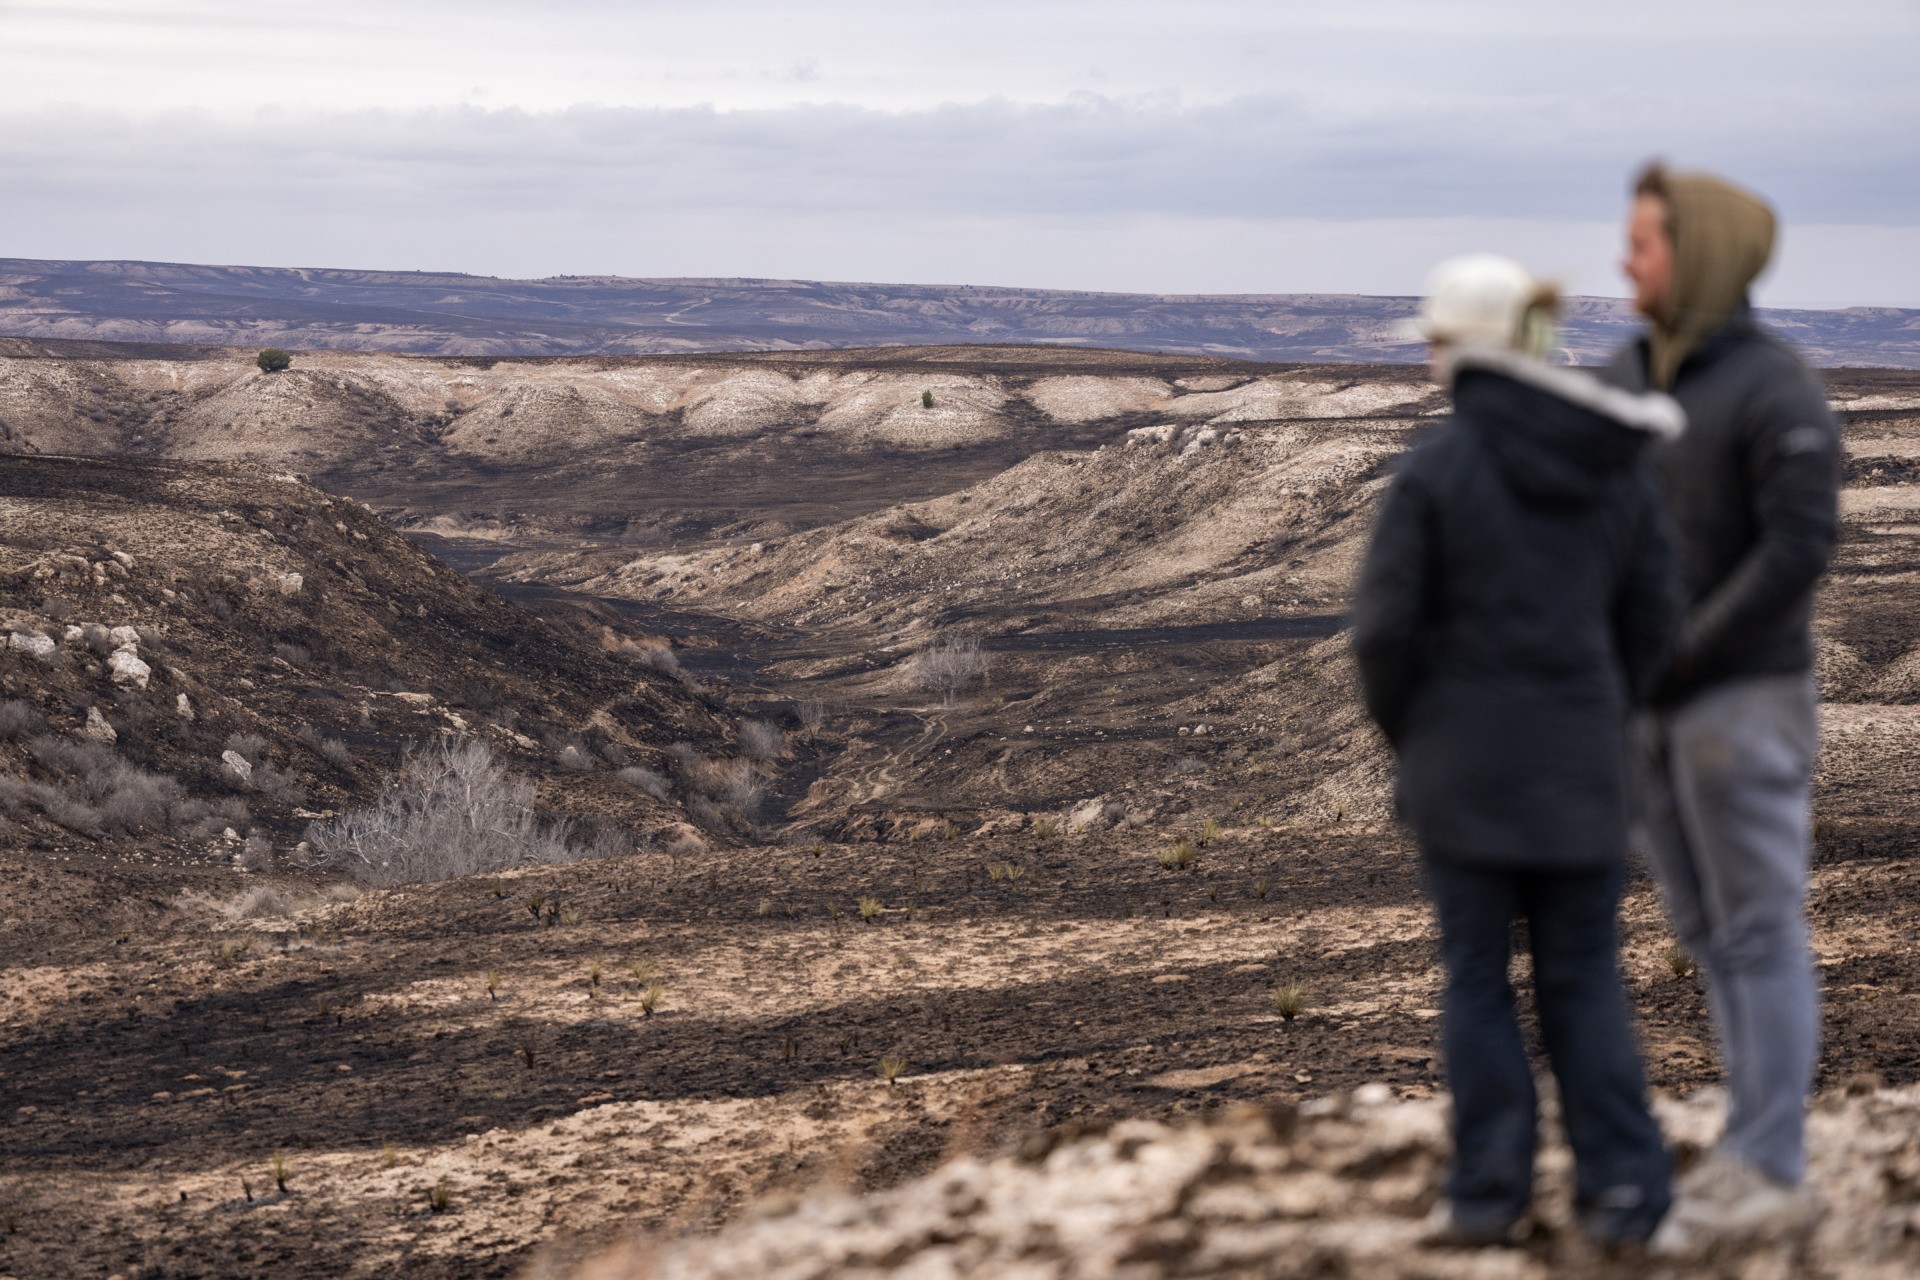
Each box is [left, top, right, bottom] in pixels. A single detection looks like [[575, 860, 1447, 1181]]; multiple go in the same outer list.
[[307, 739, 580, 885]]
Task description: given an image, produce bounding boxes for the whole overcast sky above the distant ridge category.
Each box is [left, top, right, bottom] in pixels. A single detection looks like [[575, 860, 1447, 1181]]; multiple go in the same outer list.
[[0, 0, 1920, 307]]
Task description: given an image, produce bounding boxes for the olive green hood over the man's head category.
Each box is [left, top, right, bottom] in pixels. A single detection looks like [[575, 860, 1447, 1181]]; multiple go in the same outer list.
[[1642, 169, 1774, 391]]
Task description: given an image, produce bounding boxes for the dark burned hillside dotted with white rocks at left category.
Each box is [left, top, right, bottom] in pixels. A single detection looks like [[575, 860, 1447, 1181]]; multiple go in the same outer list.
[[0, 457, 730, 932]]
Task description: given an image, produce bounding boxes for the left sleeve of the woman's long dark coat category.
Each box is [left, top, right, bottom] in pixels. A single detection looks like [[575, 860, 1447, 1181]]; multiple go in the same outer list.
[[1354, 474, 1434, 747]]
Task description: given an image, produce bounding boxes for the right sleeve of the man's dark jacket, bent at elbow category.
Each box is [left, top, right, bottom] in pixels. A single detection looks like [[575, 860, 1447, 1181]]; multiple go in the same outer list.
[[1676, 364, 1839, 674]]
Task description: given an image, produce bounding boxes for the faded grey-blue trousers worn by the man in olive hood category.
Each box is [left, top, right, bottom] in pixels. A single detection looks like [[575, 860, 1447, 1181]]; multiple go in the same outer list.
[[1636, 676, 1820, 1184]]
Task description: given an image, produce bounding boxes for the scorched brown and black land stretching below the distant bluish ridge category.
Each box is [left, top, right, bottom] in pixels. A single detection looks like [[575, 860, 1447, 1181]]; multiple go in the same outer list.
[[0, 347, 1920, 1276]]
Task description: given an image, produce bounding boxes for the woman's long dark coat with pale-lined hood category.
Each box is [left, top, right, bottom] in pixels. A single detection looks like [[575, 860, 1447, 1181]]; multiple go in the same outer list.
[[1354, 353, 1686, 871]]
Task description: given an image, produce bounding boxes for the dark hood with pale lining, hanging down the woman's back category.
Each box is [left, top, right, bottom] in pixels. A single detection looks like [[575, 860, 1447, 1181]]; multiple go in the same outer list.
[[1448, 349, 1686, 505]]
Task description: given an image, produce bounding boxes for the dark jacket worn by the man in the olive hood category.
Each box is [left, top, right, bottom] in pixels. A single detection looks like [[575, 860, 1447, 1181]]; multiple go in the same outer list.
[[1607, 309, 1839, 704]]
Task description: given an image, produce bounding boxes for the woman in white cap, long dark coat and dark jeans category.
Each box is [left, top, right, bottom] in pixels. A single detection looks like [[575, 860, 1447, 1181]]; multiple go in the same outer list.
[[1354, 255, 1684, 1244]]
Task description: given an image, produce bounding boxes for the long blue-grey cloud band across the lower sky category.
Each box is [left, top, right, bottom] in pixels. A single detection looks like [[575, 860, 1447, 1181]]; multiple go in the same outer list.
[[0, 86, 1920, 225]]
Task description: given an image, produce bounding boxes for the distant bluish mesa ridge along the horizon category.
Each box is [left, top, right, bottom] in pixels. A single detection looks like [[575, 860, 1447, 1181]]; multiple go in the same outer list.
[[0, 259, 1920, 368]]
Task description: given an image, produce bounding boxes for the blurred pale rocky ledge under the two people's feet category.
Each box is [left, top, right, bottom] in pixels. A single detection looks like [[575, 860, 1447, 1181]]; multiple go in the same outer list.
[[530, 1086, 1920, 1280]]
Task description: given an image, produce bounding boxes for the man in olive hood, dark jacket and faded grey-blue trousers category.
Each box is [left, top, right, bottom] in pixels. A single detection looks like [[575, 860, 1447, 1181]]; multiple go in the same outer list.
[[1607, 165, 1839, 1251]]
